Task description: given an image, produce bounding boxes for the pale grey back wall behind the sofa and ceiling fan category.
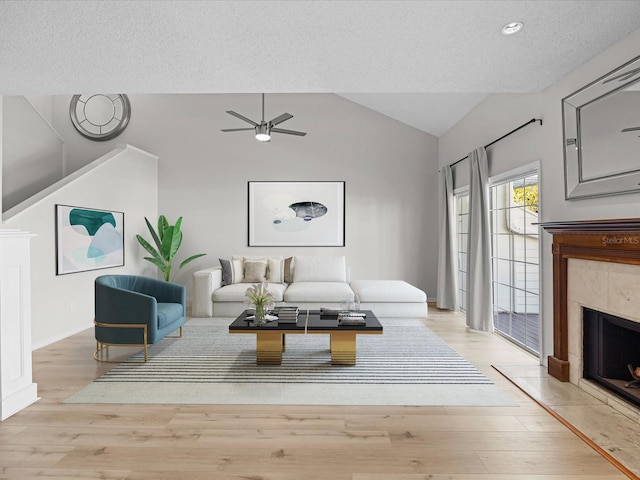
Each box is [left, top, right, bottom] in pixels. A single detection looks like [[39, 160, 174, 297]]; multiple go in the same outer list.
[[53, 94, 438, 297]]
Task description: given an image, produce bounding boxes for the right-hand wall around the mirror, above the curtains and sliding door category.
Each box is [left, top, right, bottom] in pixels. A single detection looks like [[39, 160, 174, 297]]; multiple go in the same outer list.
[[439, 26, 640, 361]]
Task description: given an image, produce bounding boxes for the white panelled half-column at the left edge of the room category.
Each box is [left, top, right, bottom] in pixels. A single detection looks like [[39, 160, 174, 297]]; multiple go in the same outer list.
[[0, 229, 38, 420]]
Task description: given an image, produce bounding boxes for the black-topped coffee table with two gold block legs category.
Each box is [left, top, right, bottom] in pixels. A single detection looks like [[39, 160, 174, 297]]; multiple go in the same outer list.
[[229, 310, 382, 365]]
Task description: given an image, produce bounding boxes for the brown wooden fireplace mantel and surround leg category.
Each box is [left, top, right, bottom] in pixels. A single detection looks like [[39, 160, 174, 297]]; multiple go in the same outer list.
[[540, 218, 640, 382]]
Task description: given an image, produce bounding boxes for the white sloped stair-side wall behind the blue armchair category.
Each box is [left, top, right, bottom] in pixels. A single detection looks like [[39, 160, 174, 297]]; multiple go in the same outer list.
[[4, 147, 158, 348]]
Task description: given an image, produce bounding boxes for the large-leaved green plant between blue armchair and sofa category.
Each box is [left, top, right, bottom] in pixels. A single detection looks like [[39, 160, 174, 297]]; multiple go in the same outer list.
[[136, 215, 206, 282]]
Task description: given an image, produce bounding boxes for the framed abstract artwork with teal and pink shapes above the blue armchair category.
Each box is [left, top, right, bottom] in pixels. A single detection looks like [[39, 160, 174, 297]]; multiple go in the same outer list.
[[56, 205, 124, 275]]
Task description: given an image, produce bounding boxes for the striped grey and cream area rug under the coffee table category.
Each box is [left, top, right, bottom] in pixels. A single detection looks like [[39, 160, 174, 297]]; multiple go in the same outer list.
[[67, 318, 513, 405]]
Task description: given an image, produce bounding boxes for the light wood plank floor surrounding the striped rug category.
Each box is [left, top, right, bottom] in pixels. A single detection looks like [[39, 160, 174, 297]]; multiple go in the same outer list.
[[0, 308, 627, 480]]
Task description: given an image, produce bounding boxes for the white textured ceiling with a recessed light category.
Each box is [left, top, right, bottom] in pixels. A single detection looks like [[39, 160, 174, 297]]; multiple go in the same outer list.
[[0, 0, 640, 135]]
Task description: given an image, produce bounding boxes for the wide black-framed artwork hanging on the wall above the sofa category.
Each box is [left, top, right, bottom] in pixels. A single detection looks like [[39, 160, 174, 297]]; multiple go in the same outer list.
[[249, 182, 345, 247]]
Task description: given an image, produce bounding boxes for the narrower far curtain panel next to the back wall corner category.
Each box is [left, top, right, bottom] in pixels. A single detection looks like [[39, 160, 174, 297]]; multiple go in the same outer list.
[[436, 165, 460, 310]]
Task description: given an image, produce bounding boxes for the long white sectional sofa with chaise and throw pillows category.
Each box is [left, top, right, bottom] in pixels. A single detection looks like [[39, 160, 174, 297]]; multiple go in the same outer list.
[[192, 255, 427, 317]]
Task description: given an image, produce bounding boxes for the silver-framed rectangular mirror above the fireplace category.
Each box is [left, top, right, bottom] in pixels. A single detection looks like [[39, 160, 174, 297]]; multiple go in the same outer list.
[[562, 57, 640, 200]]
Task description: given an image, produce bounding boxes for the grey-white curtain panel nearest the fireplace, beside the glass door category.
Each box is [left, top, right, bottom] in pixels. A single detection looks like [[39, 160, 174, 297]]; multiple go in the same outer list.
[[467, 147, 493, 332]]
